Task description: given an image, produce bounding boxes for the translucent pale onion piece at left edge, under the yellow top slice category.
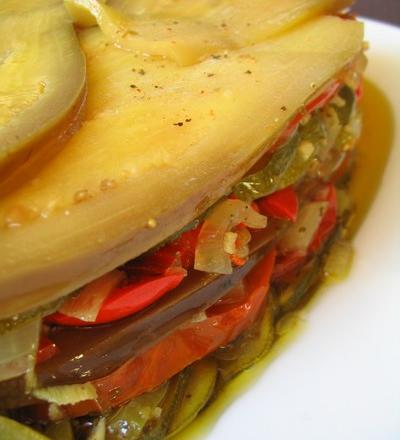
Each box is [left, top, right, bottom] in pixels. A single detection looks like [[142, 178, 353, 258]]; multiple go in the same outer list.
[[0, 316, 42, 381]]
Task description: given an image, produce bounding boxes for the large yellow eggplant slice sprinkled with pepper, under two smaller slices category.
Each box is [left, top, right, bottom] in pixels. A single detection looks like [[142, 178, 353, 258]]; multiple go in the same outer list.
[[0, 6, 363, 318]]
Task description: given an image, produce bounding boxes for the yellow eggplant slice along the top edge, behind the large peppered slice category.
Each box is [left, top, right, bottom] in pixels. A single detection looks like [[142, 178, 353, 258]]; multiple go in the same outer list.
[[67, 0, 350, 66]]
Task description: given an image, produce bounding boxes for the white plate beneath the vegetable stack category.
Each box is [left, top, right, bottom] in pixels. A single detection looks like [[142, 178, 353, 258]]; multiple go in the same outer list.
[[195, 20, 400, 440]]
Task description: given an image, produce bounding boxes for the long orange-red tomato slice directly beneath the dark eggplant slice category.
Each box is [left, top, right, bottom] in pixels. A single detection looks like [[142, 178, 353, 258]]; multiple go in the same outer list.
[[63, 250, 276, 417]]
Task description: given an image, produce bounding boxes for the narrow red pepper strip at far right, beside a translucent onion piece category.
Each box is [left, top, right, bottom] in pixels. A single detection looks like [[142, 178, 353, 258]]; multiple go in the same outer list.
[[308, 183, 338, 252]]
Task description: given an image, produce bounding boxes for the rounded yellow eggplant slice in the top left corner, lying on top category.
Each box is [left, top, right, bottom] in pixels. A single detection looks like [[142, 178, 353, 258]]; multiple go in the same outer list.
[[0, 0, 86, 184]]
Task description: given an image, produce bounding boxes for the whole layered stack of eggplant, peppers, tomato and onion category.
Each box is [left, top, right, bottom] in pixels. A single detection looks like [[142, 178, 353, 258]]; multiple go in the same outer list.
[[0, 0, 365, 440]]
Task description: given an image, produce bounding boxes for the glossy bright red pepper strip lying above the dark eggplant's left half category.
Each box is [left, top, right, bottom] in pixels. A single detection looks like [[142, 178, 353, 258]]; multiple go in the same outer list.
[[45, 269, 186, 327]]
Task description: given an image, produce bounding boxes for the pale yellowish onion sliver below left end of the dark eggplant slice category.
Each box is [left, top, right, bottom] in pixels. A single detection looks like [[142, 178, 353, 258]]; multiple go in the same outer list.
[[32, 382, 97, 405]]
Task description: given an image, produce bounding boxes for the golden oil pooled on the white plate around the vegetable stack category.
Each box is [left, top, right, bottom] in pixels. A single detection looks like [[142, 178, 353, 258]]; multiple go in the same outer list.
[[173, 81, 394, 440]]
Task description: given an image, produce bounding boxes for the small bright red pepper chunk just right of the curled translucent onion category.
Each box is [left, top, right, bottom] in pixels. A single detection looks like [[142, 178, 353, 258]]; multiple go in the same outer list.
[[257, 186, 299, 222]]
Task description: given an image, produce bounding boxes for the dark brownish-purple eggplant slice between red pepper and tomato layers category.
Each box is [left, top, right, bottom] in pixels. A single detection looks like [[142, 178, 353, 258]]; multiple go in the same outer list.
[[36, 245, 276, 387]]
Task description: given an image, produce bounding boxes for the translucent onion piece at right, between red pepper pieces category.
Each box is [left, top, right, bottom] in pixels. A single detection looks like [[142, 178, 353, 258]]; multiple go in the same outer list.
[[279, 202, 328, 253]]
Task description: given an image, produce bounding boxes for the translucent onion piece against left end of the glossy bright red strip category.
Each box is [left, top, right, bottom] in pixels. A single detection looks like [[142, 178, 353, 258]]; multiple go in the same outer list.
[[59, 270, 125, 322]]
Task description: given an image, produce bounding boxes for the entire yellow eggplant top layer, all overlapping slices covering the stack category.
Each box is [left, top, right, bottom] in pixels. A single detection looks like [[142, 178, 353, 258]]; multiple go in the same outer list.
[[0, 0, 363, 318]]
